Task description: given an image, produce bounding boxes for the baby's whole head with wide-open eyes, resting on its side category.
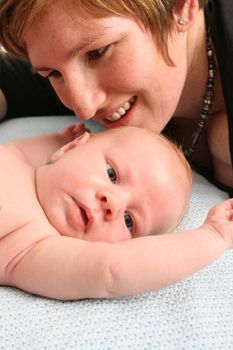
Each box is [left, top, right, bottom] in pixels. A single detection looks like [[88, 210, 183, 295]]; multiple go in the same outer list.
[[37, 127, 192, 242]]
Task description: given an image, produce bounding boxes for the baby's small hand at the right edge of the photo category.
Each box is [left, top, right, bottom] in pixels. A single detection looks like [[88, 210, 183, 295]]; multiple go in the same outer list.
[[203, 198, 233, 249]]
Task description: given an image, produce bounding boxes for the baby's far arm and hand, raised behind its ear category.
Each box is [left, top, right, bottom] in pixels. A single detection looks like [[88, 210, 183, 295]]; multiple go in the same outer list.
[[6, 124, 88, 167]]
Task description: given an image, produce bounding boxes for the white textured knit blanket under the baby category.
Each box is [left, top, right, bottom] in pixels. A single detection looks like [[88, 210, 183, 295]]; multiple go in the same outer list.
[[0, 117, 233, 350]]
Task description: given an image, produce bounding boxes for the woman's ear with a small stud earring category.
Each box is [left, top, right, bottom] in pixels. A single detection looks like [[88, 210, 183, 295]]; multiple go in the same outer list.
[[174, 0, 200, 32]]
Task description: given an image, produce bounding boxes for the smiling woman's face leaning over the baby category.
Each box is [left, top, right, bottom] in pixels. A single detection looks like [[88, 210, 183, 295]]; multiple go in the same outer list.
[[26, 4, 186, 132]]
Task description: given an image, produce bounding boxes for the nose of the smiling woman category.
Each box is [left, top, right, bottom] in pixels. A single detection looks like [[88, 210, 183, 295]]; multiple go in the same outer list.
[[63, 72, 106, 120]]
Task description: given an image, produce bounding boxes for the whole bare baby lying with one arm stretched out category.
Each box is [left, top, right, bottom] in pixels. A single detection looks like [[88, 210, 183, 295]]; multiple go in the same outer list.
[[0, 125, 232, 299]]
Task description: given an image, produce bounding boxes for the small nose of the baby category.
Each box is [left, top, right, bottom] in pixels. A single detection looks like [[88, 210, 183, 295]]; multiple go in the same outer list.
[[97, 191, 123, 221]]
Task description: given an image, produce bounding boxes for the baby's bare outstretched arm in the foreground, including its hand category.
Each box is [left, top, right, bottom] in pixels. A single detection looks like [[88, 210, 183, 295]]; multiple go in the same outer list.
[[5, 199, 233, 299]]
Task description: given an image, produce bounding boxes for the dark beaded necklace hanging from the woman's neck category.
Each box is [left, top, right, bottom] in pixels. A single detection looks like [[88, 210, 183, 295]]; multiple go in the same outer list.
[[184, 28, 215, 161]]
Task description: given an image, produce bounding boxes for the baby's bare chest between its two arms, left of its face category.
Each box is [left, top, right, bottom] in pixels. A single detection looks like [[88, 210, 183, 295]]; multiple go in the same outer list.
[[0, 145, 59, 284]]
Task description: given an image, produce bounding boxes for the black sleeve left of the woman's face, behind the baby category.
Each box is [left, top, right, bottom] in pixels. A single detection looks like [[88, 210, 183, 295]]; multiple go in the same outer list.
[[0, 55, 74, 118]]
